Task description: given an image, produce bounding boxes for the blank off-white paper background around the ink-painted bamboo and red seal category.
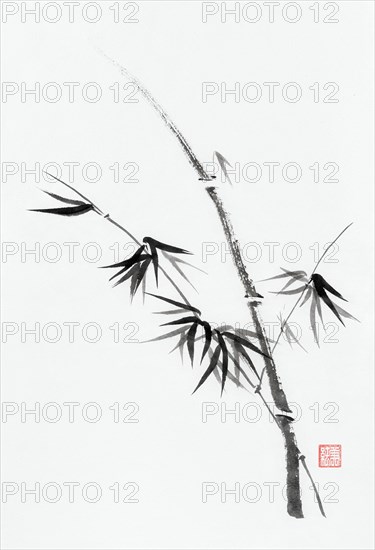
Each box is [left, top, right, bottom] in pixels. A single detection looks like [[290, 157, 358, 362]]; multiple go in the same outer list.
[[1, 1, 374, 550]]
